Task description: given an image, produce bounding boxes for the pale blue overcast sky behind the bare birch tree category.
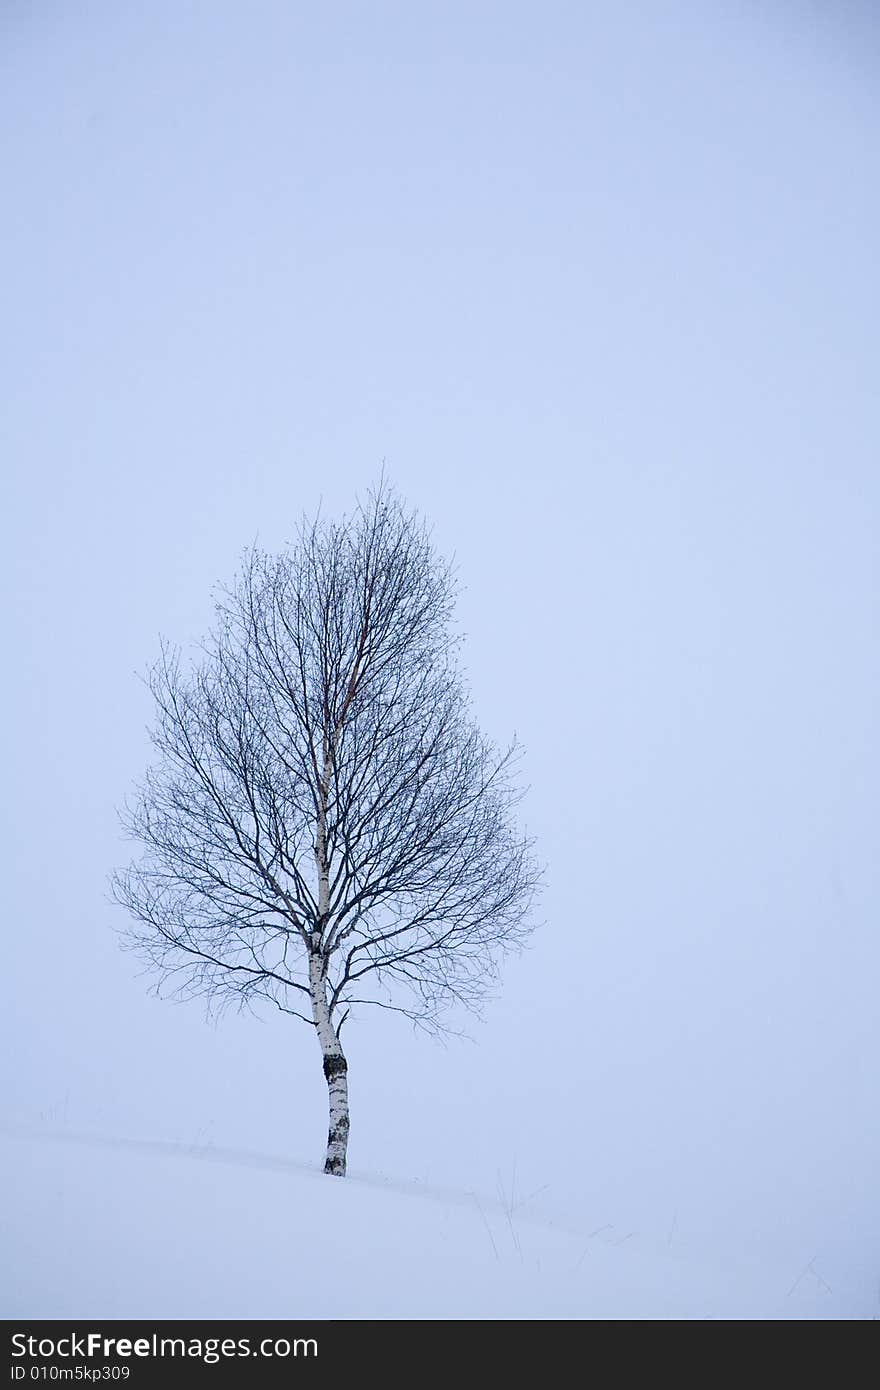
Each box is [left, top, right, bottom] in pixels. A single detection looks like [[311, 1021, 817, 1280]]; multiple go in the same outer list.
[[0, 0, 880, 1273]]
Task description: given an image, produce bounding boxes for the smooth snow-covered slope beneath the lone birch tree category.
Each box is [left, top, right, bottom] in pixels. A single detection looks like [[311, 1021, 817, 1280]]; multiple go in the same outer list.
[[0, 1131, 876, 1319]]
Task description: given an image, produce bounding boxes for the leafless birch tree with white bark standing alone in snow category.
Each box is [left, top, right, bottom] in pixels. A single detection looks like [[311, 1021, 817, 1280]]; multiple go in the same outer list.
[[113, 484, 537, 1176]]
